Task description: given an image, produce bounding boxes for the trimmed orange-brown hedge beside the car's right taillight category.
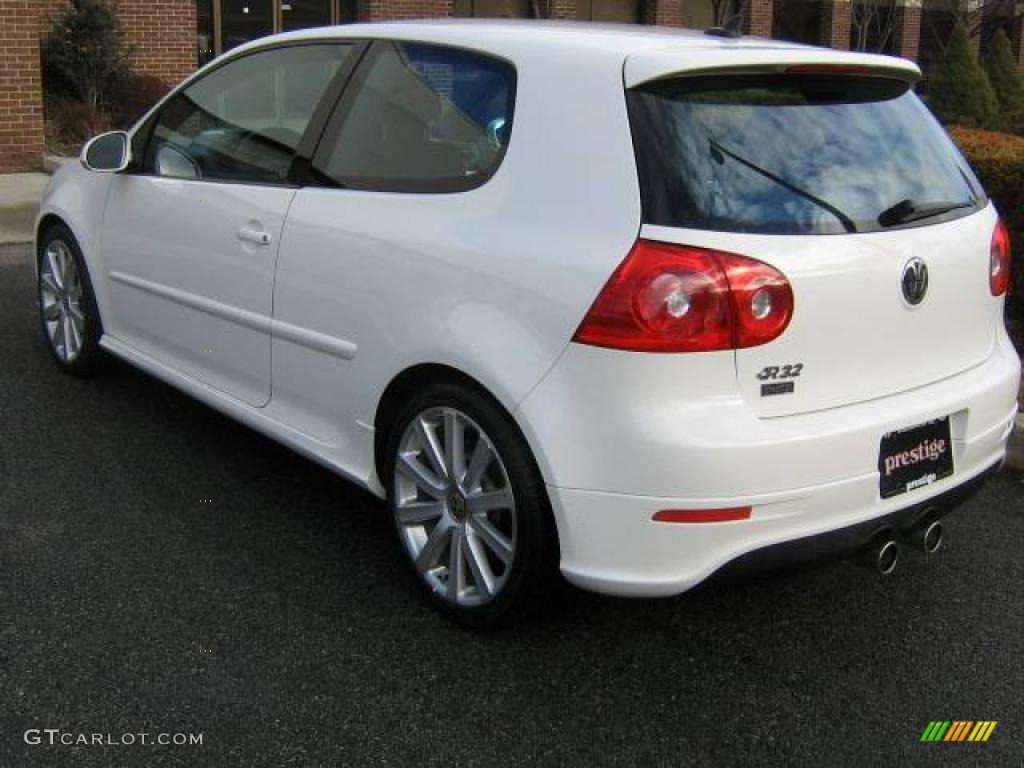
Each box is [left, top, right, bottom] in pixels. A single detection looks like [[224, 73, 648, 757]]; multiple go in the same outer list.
[[949, 128, 1024, 311]]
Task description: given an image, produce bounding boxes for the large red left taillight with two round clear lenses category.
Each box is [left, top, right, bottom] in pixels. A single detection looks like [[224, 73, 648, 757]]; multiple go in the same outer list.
[[573, 240, 793, 352]]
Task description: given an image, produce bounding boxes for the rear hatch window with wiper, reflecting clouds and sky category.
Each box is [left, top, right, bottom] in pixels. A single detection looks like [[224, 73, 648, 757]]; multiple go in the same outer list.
[[627, 75, 984, 234]]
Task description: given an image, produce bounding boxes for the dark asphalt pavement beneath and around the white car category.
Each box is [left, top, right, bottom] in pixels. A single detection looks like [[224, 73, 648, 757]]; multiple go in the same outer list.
[[0, 247, 1024, 768]]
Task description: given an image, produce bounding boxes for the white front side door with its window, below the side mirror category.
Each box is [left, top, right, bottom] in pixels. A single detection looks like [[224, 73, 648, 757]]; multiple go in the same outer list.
[[102, 42, 355, 407]]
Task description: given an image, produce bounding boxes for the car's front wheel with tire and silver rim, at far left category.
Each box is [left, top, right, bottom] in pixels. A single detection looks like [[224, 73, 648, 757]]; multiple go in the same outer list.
[[37, 224, 101, 376]]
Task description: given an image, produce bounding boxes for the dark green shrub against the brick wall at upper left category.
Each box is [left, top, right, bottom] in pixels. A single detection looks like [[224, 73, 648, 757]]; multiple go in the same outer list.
[[41, 0, 132, 109]]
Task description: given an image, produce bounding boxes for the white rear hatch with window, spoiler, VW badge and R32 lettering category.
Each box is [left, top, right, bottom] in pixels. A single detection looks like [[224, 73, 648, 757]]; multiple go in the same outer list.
[[626, 48, 997, 417]]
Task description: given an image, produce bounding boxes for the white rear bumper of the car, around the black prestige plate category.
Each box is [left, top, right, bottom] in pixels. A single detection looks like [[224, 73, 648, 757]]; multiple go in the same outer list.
[[520, 333, 1020, 596]]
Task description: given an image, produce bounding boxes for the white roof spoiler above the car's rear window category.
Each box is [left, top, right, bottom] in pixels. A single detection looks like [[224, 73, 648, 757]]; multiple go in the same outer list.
[[623, 44, 921, 88]]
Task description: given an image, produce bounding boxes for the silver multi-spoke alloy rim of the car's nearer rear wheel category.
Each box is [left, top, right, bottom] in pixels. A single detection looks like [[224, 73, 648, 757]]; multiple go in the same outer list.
[[394, 408, 516, 607]]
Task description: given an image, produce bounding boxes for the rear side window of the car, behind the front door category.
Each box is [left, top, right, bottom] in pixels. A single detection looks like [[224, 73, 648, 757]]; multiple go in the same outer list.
[[313, 42, 515, 193]]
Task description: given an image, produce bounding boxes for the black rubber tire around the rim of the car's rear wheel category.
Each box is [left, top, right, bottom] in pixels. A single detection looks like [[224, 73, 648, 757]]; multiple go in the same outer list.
[[381, 382, 558, 629]]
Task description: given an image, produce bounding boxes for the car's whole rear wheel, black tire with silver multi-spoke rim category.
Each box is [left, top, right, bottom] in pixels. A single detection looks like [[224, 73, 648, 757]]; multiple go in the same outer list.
[[387, 385, 556, 627]]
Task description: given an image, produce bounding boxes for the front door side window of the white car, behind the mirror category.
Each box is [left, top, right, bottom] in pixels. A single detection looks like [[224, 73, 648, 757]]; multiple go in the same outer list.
[[142, 43, 353, 184]]
